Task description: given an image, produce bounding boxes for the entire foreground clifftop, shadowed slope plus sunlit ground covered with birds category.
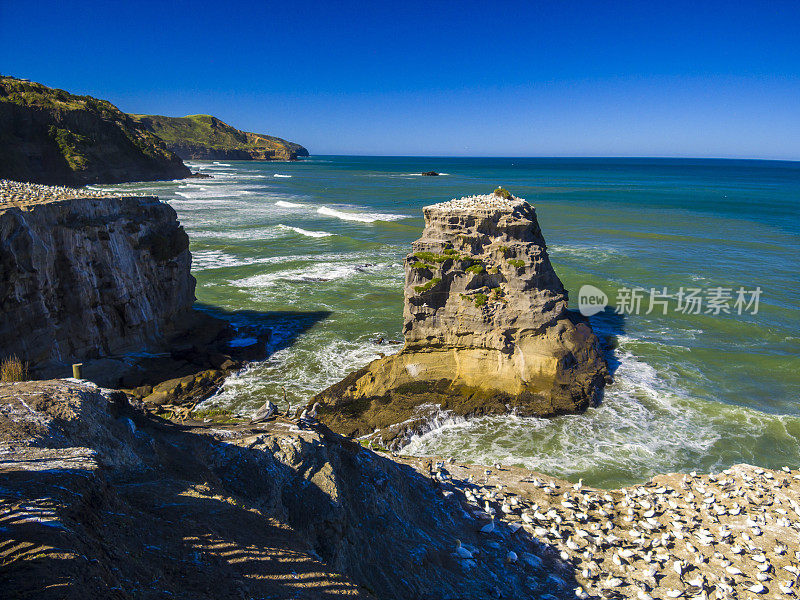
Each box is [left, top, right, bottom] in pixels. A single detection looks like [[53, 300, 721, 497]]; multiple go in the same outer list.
[[0, 381, 800, 600]]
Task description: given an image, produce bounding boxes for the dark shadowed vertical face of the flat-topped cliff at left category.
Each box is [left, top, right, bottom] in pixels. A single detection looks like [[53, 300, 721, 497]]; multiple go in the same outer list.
[[0, 196, 195, 365]]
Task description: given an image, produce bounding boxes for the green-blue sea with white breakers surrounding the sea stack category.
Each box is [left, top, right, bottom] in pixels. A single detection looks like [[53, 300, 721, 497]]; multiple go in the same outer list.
[[97, 156, 800, 486]]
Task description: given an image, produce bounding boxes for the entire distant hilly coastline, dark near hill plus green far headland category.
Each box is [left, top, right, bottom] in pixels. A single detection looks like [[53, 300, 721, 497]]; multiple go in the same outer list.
[[0, 75, 308, 186]]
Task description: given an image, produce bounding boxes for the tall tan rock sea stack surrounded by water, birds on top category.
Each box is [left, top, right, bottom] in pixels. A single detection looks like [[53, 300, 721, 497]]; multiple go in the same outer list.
[[316, 189, 609, 446]]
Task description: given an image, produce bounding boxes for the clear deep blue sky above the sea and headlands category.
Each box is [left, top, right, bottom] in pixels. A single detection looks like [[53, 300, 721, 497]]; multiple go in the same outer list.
[[0, 0, 800, 160]]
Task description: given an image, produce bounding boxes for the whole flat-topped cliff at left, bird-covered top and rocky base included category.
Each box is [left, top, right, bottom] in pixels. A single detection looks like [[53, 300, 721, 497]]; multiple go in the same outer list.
[[0, 180, 269, 407]]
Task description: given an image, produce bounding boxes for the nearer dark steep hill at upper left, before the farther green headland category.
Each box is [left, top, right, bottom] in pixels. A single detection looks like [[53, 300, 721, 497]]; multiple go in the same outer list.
[[0, 76, 191, 186]]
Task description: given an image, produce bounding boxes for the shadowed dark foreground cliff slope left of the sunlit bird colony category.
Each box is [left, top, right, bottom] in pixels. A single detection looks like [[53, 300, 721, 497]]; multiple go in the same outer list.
[[0, 381, 576, 600]]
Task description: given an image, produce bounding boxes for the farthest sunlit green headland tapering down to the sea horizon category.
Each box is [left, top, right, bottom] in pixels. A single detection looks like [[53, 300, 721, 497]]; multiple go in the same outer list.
[[130, 115, 308, 160]]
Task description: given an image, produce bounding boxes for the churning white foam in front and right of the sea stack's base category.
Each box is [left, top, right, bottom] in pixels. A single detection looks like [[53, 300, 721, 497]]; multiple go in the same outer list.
[[404, 340, 792, 484]]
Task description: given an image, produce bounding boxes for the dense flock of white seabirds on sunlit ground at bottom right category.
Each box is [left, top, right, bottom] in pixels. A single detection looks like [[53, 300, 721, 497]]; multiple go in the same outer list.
[[431, 462, 800, 600]]
